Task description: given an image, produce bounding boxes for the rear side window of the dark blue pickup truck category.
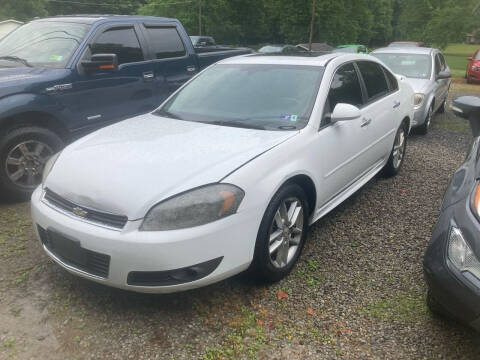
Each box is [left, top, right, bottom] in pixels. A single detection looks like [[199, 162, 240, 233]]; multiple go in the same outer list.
[[146, 27, 186, 59]]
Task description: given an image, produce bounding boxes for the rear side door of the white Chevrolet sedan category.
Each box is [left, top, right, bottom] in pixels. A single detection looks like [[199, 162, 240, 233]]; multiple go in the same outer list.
[[357, 61, 402, 166]]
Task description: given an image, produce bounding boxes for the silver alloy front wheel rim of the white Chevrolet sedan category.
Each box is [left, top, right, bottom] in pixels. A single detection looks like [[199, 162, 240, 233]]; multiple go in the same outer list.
[[268, 197, 304, 268]]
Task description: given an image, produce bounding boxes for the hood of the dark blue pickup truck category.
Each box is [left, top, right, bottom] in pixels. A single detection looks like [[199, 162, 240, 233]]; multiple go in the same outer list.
[[0, 66, 70, 99]]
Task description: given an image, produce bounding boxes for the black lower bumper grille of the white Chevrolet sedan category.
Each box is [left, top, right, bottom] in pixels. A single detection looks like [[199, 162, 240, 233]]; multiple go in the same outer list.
[[37, 225, 110, 278]]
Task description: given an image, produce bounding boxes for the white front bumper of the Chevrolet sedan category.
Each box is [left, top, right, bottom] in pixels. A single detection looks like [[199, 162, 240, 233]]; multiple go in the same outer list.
[[31, 188, 262, 293]]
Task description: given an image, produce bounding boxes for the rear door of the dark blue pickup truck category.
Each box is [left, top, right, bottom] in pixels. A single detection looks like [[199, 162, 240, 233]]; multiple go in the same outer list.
[[142, 23, 198, 105]]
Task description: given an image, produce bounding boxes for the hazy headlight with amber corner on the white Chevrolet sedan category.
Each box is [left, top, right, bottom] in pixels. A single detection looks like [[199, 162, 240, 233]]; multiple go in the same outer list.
[[140, 184, 245, 231]]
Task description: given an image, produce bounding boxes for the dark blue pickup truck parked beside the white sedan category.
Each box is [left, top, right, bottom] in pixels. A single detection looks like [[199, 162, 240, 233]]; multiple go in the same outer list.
[[0, 15, 251, 198]]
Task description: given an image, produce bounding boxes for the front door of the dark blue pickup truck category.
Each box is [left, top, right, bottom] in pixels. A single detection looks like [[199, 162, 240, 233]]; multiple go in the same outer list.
[[65, 23, 156, 129]]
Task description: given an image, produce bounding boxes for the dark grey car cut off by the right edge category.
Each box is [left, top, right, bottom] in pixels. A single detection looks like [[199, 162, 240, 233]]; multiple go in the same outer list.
[[423, 96, 480, 331]]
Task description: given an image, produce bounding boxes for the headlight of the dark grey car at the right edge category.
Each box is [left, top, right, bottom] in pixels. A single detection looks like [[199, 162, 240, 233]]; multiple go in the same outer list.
[[448, 227, 480, 279]]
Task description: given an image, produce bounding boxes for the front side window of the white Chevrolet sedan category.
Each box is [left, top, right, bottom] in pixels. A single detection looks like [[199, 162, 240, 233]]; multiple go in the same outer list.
[[326, 63, 363, 112]]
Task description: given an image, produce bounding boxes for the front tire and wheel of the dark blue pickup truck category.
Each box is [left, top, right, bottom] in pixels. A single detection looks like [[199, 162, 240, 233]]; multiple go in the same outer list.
[[0, 126, 64, 200]]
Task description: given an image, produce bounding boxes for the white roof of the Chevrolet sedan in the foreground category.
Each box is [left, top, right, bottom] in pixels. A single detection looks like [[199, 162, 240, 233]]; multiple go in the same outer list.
[[218, 52, 378, 66]]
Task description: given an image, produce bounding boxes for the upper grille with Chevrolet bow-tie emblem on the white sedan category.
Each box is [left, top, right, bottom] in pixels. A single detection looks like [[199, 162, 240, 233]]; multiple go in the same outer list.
[[44, 189, 128, 229]]
